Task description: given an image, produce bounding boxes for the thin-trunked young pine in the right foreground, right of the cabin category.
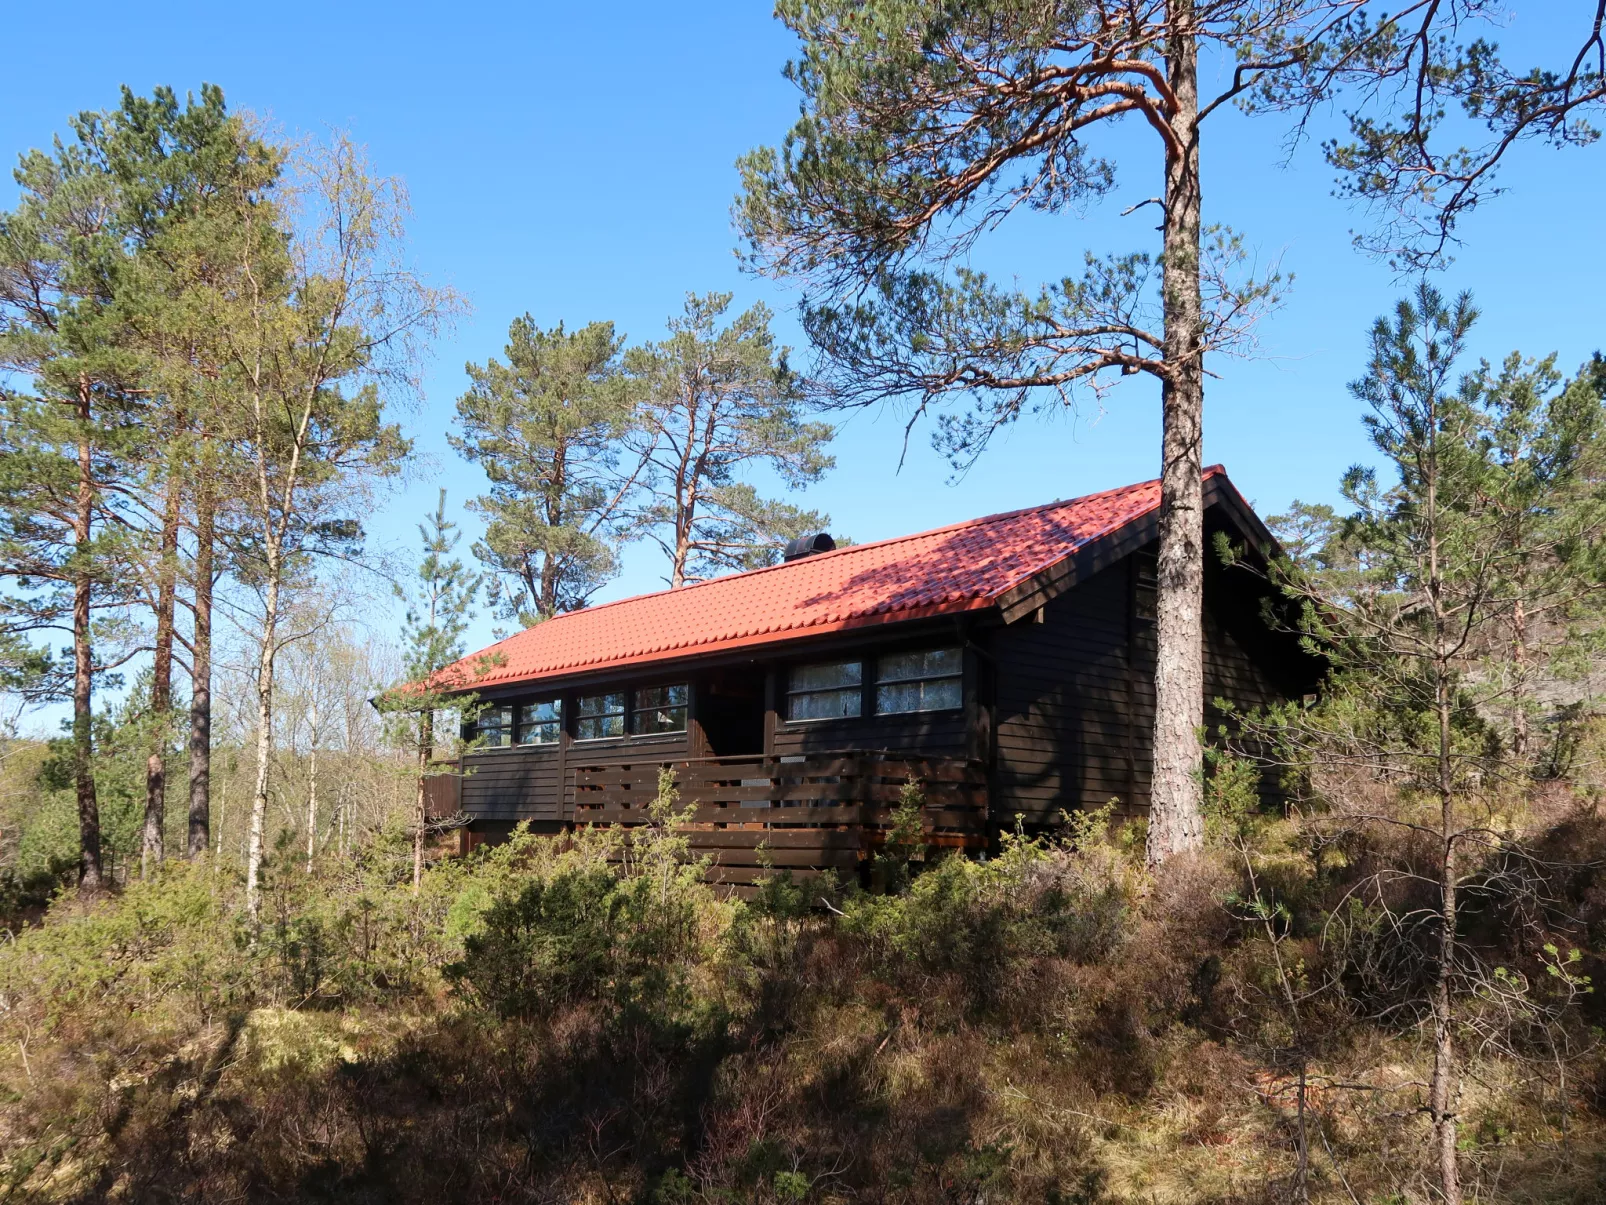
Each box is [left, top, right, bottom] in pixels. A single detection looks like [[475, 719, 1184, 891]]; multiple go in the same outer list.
[[1251, 284, 1606, 1202]]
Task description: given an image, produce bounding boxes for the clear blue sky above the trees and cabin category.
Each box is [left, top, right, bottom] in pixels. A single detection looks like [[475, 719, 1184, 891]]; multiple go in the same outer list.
[[0, 0, 1606, 661]]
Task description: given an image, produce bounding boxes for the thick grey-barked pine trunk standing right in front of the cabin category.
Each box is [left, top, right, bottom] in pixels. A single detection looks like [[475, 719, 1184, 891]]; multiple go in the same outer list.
[[1148, 0, 1205, 863]]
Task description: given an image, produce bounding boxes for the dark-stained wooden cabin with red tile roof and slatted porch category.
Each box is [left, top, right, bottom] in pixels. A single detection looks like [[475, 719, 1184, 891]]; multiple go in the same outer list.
[[435, 466, 1315, 885]]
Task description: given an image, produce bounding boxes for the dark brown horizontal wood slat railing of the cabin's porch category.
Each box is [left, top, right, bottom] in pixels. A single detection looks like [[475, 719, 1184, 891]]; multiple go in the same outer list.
[[567, 754, 988, 888]]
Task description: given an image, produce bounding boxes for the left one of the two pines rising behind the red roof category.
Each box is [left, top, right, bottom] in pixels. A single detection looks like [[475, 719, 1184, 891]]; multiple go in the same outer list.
[[448, 315, 641, 625]]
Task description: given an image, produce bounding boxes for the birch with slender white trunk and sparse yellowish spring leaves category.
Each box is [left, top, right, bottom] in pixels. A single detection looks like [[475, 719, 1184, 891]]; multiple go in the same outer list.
[[212, 138, 453, 917]]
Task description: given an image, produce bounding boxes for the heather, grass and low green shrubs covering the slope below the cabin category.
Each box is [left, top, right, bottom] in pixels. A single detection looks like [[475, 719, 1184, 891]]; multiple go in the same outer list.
[[0, 766, 1606, 1205]]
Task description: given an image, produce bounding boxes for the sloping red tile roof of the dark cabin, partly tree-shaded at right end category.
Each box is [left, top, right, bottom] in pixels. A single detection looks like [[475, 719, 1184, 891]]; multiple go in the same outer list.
[[442, 464, 1225, 688]]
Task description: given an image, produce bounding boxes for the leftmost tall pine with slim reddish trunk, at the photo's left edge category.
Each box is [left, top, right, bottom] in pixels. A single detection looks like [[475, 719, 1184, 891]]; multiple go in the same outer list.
[[0, 96, 151, 890]]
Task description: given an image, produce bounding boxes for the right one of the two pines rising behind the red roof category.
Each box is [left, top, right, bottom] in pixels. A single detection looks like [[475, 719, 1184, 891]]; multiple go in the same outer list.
[[626, 292, 835, 586]]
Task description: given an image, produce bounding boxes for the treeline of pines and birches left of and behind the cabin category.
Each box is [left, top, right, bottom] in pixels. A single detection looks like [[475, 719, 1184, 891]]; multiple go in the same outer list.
[[0, 87, 832, 903]]
